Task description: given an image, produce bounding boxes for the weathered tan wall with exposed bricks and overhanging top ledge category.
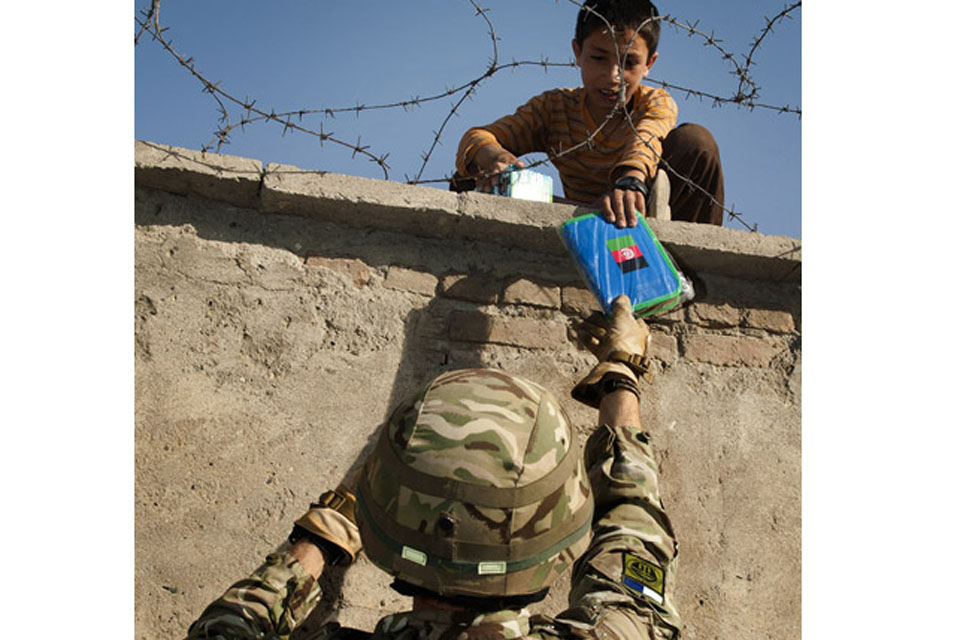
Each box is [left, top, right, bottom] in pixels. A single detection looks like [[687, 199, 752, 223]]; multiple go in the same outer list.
[[135, 142, 800, 640]]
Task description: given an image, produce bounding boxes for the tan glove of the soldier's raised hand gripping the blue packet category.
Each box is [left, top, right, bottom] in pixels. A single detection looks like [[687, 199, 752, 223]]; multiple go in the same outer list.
[[571, 295, 653, 408]]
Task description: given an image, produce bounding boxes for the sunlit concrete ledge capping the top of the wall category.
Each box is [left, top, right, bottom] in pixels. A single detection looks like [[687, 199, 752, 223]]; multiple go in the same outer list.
[[134, 140, 801, 282]]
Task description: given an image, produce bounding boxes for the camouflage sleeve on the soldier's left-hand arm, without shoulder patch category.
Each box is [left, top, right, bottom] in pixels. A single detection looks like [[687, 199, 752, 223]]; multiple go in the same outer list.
[[186, 548, 321, 640]]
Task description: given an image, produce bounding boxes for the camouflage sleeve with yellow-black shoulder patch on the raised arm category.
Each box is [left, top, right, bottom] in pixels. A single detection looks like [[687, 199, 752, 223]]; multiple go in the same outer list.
[[557, 425, 680, 638]]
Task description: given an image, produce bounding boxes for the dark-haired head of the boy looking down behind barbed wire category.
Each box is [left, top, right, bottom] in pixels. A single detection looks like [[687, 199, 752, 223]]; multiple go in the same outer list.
[[573, 0, 660, 114]]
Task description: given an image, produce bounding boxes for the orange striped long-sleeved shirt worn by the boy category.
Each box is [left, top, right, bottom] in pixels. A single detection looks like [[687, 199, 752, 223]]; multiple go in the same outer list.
[[457, 85, 677, 202]]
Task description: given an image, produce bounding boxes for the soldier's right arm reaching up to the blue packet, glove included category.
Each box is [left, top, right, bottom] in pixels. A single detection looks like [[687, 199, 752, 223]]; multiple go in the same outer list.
[[557, 296, 681, 639]]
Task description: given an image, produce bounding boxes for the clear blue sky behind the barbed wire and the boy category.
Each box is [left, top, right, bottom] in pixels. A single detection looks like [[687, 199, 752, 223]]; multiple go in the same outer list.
[[134, 0, 802, 237]]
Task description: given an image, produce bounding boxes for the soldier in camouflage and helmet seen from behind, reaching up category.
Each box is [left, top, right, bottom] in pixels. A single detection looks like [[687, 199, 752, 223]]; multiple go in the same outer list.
[[188, 296, 680, 640]]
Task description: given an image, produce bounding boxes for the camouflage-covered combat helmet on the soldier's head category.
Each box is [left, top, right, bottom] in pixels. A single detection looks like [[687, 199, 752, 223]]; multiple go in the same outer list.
[[357, 369, 593, 597]]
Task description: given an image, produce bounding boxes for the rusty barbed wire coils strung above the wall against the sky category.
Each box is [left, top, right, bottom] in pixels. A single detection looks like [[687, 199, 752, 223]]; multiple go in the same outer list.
[[134, 0, 802, 231]]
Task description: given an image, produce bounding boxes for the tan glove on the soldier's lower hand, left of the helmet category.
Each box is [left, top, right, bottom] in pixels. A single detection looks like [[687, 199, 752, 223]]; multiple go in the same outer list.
[[289, 487, 363, 565]]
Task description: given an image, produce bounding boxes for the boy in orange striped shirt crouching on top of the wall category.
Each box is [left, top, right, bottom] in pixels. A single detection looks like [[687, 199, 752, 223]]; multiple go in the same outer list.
[[452, 0, 723, 227]]
